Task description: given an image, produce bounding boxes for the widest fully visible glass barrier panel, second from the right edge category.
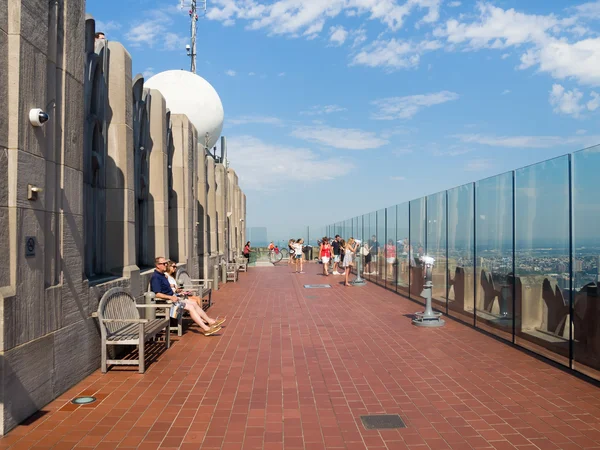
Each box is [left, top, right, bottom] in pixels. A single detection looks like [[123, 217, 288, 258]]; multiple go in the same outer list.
[[514, 156, 571, 366]]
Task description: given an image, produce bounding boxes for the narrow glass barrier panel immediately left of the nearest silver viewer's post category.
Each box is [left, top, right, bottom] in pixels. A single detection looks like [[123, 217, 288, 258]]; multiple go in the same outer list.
[[408, 197, 426, 303]]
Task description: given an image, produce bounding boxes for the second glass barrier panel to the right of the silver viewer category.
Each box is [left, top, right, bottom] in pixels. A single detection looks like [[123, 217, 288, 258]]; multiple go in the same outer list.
[[447, 183, 475, 324]]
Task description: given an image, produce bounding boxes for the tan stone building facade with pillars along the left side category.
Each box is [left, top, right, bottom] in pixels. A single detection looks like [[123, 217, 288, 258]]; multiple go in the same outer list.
[[0, 0, 245, 434]]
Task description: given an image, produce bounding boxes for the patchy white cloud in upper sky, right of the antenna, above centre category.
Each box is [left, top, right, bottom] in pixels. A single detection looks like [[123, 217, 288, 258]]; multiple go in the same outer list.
[[351, 38, 442, 70]]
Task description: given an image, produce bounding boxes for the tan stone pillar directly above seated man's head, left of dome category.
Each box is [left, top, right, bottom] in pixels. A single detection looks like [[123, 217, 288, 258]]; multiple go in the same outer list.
[[148, 89, 169, 258]]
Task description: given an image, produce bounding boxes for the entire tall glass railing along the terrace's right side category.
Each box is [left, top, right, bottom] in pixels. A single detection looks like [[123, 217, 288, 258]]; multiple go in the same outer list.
[[324, 146, 600, 378]]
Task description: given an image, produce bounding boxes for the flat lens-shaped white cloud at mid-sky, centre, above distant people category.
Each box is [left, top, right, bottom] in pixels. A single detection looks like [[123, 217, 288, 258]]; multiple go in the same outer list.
[[292, 125, 389, 150]]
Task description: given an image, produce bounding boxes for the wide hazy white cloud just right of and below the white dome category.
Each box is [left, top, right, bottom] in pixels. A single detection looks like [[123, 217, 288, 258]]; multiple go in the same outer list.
[[228, 136, 354, 191]]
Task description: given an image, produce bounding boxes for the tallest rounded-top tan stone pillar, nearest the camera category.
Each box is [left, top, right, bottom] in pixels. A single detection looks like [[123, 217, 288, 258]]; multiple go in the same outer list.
[[106, 42, 139, 286]]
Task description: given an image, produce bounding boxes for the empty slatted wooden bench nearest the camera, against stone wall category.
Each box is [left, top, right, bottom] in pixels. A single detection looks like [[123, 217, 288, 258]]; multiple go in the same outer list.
[[95, 288, 171, 373]]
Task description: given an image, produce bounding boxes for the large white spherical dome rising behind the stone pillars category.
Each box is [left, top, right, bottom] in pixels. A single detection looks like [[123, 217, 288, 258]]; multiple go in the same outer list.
[[144, 70, 224, 149]]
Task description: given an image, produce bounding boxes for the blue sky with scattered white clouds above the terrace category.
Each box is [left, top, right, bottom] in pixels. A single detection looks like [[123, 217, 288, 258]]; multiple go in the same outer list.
[[87, 0, 600, 241]]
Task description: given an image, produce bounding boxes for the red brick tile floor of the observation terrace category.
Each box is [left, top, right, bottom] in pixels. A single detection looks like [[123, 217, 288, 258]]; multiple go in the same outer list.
[[0, 264, 600, 450]]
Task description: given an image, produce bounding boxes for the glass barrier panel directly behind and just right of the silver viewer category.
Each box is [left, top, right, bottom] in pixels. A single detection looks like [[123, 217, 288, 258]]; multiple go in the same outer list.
[[426, 191, 448, 312]]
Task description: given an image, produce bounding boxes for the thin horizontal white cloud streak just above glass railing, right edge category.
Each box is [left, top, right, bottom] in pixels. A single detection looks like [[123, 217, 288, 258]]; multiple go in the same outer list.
[[452, 134, 600, 148]]
